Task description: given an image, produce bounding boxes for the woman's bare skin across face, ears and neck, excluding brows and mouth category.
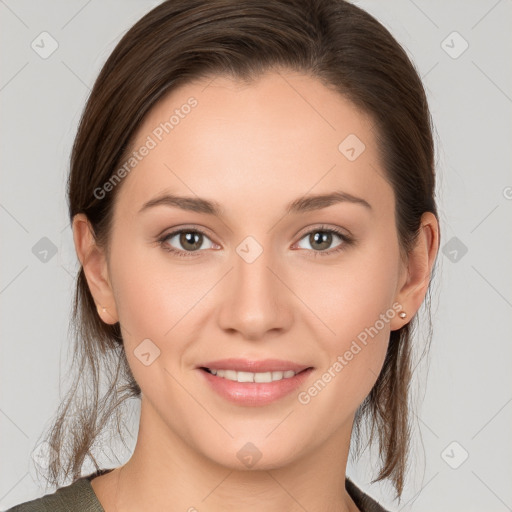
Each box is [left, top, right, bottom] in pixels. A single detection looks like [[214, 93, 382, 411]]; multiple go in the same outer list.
[[73, 71, 438, 512]]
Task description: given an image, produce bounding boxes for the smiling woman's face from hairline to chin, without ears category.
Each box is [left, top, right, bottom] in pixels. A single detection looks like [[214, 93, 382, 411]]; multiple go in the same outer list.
[[95, 72, 414, 468]]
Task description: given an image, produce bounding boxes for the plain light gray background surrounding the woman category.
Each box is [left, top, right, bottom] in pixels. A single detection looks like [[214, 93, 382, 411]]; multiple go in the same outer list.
[[0, 0, 512, 512]]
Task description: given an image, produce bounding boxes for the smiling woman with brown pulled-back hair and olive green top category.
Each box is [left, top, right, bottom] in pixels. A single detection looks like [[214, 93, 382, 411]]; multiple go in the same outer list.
[[8, 0, 439, 512]]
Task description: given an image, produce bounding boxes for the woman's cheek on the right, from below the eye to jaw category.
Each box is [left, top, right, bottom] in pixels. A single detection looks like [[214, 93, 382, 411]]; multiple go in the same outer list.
[[292, 240, 398, 411]]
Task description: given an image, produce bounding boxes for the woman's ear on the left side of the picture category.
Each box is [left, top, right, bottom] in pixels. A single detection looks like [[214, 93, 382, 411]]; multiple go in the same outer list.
[[73, 213, 119, 324]]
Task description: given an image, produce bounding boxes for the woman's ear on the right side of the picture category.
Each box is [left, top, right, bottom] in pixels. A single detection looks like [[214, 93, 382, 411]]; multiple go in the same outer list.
[[391, 212, 439, 331]]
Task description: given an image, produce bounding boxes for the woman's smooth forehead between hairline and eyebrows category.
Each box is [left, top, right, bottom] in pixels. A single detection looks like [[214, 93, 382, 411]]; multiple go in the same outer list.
[[113, 72, 393, 218]]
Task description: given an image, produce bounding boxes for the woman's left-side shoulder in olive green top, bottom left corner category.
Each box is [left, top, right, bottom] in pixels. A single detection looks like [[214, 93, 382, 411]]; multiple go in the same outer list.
[[7, 476, 104, 512]]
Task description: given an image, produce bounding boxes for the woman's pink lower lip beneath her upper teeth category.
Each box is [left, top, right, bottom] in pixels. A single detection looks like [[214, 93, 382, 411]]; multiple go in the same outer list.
[[198, 368, 313, 406]]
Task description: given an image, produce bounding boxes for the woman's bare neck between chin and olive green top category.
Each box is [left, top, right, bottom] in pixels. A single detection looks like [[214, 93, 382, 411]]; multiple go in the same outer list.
[[111, 400, 358, 512]]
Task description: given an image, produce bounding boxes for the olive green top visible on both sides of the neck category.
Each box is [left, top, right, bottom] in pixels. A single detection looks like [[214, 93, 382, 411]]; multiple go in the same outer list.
[[7, 469, 388, 512]]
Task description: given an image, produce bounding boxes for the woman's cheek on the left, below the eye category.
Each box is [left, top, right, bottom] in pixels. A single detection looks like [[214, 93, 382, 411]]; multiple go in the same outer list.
[[111, 240, 218, 396]]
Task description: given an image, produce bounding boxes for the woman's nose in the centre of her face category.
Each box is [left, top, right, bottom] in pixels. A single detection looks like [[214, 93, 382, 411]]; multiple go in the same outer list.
[[218, 239, 293, 341]]
